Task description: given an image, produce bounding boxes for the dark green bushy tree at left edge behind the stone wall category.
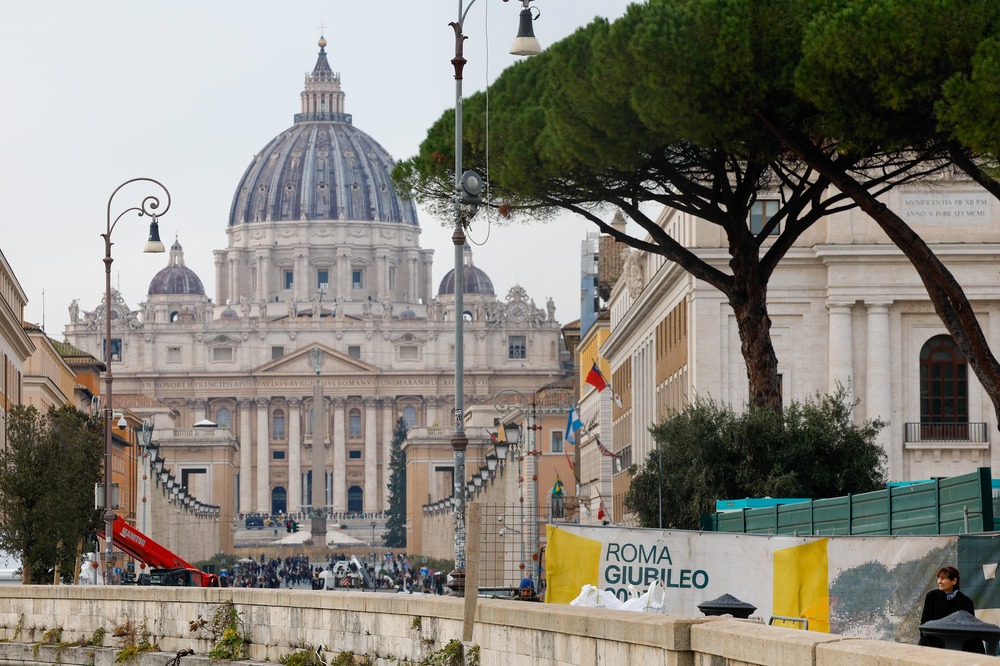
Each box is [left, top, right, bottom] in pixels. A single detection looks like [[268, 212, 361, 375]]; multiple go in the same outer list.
[[0, 405, 104, 584]]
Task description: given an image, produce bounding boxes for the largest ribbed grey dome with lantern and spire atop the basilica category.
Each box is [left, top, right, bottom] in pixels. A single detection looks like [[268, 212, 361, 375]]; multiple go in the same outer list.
[[229, 38, 418, 226]]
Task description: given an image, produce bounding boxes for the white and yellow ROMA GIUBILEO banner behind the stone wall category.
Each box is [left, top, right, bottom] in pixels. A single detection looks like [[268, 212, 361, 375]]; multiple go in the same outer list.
[[545, 525, 976, 643]]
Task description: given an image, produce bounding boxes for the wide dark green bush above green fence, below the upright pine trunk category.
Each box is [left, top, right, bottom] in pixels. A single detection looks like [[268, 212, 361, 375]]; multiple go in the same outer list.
[[625, 388, 886, 529]]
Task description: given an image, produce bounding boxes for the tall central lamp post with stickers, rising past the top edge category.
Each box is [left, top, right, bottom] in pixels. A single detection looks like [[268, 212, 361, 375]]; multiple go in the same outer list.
[[448, 0, 541, 592]]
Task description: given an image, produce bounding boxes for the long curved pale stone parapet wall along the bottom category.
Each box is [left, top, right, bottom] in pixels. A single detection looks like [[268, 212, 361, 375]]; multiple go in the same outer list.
[[0, 586, 996, 666]]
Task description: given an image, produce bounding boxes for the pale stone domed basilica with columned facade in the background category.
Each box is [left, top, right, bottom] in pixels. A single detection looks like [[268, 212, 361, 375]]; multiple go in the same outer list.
[[66, 39, 561, 515]]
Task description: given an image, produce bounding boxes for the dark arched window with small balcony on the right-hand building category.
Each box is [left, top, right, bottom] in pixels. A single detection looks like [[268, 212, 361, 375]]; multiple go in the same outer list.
[[920, 335, 969, 439]]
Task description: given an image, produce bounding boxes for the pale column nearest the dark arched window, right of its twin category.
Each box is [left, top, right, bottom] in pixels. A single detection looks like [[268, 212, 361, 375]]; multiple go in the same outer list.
[[865, 302, 903, 474]]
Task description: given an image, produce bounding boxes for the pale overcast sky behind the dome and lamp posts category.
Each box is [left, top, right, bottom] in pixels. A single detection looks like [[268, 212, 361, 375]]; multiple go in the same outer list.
[[0, 0, 631, 340]]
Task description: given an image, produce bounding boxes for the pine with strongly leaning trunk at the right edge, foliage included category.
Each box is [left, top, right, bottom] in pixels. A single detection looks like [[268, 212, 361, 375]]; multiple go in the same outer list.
[[772, 0, 1000, 426]]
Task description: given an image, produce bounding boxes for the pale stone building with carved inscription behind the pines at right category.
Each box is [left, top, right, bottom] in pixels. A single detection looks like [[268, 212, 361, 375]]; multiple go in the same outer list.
[[580, 174, 1000, 522]]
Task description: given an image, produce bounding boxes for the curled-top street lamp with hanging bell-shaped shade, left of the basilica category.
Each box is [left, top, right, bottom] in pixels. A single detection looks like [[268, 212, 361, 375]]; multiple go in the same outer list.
[[101, 178, 170, 583]]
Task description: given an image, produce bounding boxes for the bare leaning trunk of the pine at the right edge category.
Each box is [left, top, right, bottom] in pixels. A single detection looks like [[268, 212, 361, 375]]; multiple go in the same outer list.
[[769, 124, 1000, 428]]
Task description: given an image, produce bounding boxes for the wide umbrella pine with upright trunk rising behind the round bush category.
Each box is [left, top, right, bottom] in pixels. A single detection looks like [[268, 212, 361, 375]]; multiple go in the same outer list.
[[394, 0, 928, 410]]
